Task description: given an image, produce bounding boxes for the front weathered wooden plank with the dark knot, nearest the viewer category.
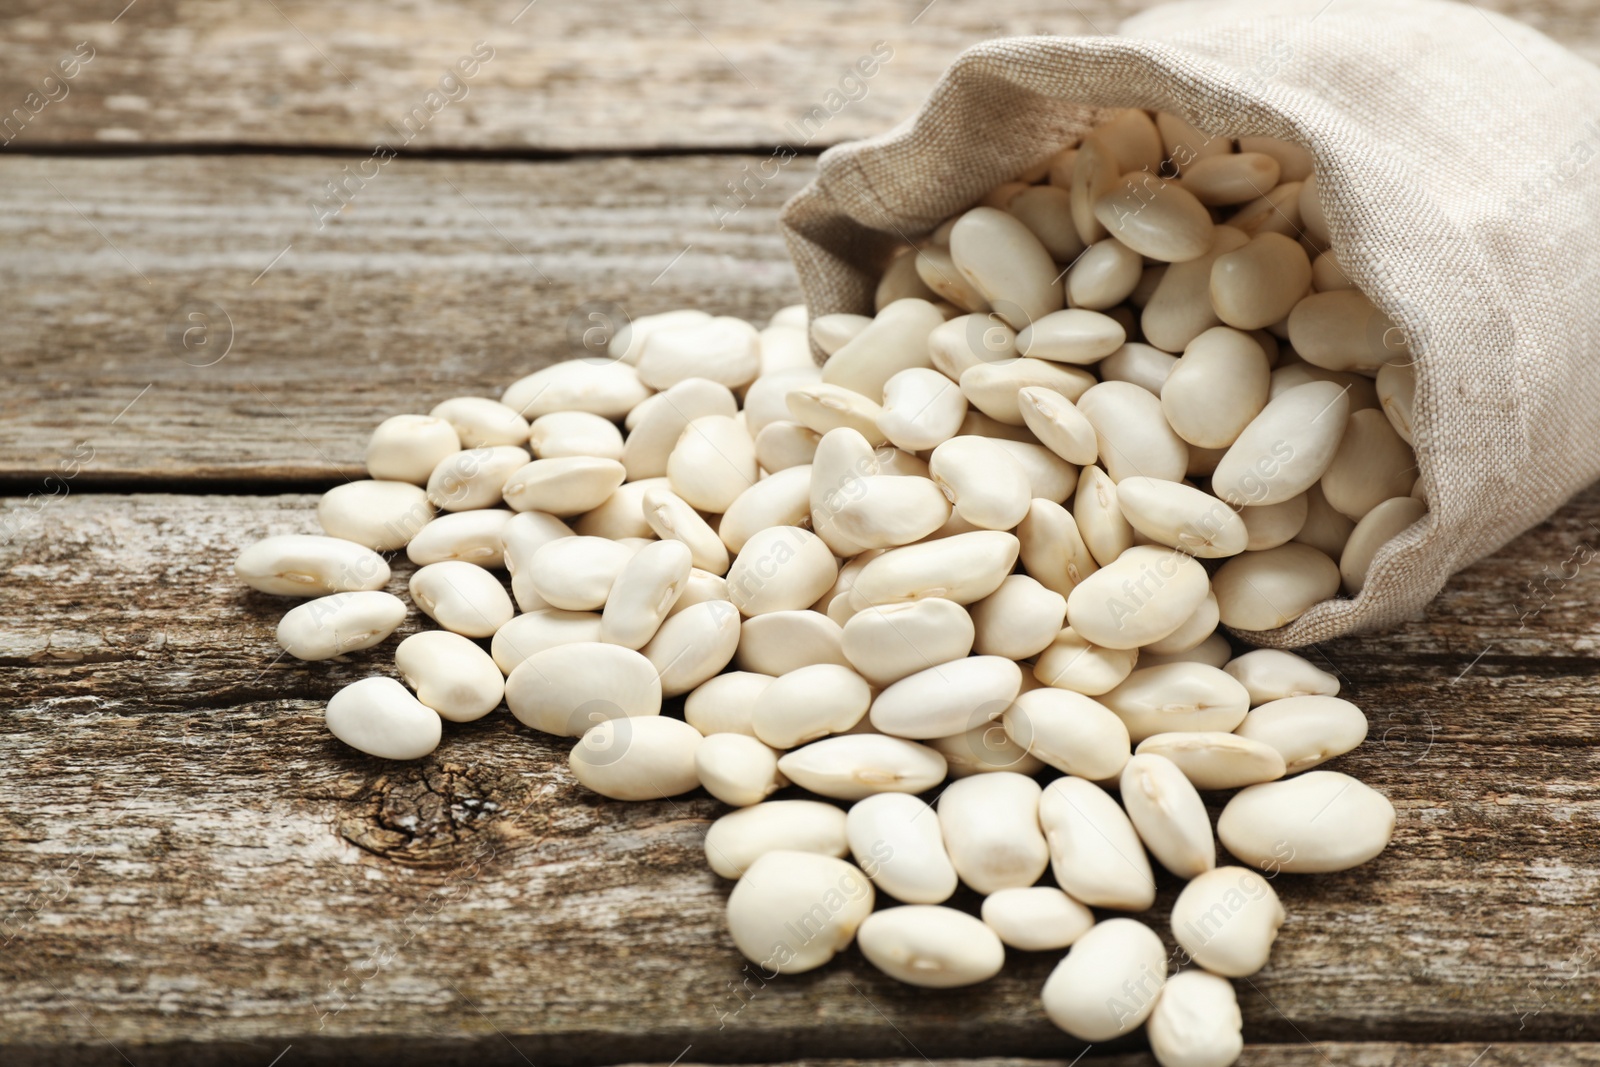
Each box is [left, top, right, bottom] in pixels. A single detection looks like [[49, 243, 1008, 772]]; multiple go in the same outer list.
[[0, 496, 1600, 1064]]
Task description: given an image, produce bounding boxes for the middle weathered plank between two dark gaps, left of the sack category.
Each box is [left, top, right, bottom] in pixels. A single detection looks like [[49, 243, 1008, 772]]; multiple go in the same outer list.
[[0, 150, 811, 493]]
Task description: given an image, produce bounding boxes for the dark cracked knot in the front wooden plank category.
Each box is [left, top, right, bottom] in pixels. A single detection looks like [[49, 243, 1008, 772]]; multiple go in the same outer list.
[[338, 761, 525, 867]]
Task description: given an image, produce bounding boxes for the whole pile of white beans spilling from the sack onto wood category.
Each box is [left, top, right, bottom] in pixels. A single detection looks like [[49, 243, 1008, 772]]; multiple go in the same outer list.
[[228, 110, 1426, 1067]]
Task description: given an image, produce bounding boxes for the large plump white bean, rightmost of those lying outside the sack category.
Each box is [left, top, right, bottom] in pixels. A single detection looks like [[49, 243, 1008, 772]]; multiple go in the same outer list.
[[1216, 771, 1395, 873]]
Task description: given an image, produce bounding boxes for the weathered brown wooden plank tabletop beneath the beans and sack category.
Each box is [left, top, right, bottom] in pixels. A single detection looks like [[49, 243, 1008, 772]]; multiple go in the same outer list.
[[0, 0, 1600, 1067]]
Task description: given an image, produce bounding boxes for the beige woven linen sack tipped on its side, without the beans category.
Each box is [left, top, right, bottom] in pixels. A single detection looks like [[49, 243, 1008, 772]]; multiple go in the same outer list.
[[781, 0, 1600, 646]]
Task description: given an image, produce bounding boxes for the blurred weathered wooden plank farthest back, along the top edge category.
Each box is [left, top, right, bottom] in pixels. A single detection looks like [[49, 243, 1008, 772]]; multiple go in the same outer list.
[[0, 0, 1600, 150]]
